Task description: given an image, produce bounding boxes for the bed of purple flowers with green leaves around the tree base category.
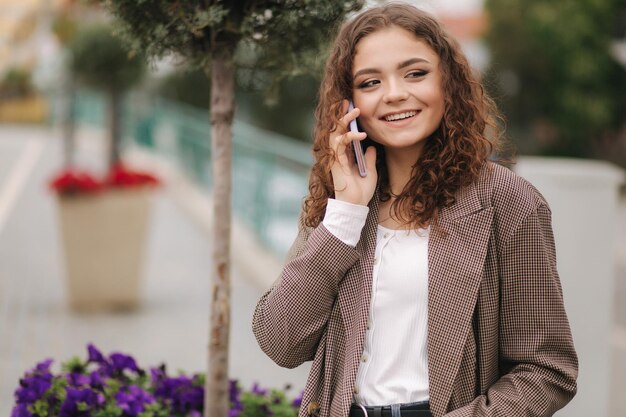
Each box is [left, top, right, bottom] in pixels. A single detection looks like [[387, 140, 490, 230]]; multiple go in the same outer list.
[[11, 344, 302, 417]]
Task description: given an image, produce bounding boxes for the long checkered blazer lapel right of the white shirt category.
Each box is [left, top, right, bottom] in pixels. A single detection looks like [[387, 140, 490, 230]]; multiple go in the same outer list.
[[428, 186, 493, 415]]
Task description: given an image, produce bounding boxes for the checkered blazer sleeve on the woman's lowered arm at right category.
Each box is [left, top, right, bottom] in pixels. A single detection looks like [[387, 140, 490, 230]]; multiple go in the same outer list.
[[446, 203, 578, 417]]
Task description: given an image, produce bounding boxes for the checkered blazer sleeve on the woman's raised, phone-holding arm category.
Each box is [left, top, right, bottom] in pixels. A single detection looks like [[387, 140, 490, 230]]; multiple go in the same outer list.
[[252, 214, 359, 368]]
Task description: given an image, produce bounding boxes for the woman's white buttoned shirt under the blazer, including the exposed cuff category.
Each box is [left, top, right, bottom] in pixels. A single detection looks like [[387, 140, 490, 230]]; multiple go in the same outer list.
[[323, 199, 429, 406]]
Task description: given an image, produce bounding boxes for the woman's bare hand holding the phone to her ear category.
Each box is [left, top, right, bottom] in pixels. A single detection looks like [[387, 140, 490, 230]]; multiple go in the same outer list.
[[329, 100, 378, 206]]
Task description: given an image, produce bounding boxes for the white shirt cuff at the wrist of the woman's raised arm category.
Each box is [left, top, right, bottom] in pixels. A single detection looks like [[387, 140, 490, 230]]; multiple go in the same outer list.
[[322, 198, 370, 248]]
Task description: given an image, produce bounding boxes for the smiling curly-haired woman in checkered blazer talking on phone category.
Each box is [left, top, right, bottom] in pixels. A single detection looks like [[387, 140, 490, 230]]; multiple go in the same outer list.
[[253, 4, 577, 417]]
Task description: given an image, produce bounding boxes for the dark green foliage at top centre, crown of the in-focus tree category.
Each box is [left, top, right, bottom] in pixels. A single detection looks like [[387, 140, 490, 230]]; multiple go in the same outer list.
[[103, 0, 364, 86]]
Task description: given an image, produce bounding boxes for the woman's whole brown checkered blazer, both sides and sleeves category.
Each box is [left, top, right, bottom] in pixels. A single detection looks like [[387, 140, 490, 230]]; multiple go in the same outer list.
[[253, 163, 578, 417]]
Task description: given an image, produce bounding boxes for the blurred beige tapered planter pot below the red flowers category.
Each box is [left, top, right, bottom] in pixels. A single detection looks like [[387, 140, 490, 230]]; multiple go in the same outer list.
[[58, 187, 153, 311]]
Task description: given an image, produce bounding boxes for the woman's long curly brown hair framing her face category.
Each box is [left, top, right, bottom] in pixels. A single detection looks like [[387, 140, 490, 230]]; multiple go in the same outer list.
[[304, 3, 500, 227]]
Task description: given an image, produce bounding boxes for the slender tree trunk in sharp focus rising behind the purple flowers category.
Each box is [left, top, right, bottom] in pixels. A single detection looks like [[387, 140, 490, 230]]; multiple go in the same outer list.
[[204, 45, 235, 417]]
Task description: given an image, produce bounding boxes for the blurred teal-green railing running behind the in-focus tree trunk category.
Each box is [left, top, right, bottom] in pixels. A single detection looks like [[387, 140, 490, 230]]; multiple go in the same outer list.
[[74, 91, 312, 254]]
